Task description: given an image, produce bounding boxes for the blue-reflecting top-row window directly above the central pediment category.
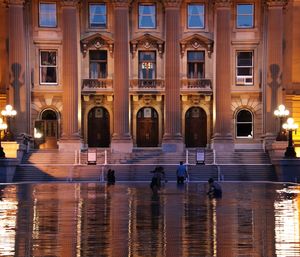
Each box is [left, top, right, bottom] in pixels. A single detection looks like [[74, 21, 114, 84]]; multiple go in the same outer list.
[[139, 4, 156, 29]]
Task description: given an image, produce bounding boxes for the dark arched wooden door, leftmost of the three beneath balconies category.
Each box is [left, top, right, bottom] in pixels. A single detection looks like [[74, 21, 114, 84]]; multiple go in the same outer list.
[[88, 107, 110, 147]]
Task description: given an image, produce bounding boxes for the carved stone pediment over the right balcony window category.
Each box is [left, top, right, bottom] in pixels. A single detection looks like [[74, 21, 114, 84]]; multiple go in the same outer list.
[[180, 34, 214, 58]]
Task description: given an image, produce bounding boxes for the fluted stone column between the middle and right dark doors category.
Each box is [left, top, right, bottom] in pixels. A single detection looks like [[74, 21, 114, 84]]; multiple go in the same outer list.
[[162, 0, 184, 152]]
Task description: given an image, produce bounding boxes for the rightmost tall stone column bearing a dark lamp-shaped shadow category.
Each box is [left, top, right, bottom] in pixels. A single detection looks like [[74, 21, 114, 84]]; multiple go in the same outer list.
[[264, 0, 287, 149]]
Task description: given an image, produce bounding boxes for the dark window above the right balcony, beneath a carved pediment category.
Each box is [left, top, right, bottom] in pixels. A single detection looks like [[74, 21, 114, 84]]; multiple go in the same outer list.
[[187, 51, 205, 79]]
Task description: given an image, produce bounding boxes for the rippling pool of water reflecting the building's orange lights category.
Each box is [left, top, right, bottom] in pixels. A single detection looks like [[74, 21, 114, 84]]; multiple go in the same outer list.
[[0, 183, 300, 257]]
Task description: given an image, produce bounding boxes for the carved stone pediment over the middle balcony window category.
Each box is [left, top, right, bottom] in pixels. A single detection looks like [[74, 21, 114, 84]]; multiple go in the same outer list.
[[130, 33, 164, 58]]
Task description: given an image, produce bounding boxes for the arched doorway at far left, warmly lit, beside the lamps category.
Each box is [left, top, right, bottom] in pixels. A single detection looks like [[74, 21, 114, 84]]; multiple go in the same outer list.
[[35, 109, 58, 149]]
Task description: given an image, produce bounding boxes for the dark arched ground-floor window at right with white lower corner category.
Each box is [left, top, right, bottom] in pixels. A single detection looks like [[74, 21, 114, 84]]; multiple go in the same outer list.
[[236, 110, 253, 138]]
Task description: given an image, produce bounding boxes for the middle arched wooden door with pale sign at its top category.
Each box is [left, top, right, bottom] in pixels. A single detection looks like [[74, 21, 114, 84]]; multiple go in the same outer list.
[[136, 107, 158, 147]]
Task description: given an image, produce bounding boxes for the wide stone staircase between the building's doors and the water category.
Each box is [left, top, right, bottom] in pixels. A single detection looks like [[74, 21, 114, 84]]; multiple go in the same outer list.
[[14, 148, 276, 182]]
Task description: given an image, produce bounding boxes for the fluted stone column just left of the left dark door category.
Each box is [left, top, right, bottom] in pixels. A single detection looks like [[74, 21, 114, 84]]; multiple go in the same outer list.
[[59, 0, 80, 151]]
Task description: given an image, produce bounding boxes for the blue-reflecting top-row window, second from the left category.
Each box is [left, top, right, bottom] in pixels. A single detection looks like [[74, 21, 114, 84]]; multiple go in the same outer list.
[[89, 4, 106, 28]]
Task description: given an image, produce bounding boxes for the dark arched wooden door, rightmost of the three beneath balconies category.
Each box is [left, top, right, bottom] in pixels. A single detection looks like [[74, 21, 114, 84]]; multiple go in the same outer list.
[[185, 107, 207, 147]]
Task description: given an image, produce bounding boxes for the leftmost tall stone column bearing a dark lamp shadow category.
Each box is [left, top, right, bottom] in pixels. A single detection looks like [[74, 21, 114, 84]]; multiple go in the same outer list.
[[7, 0, 30, 138]]
